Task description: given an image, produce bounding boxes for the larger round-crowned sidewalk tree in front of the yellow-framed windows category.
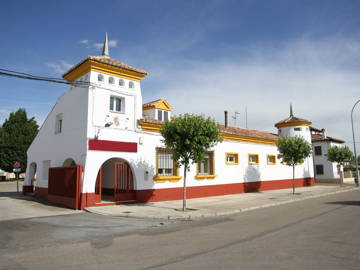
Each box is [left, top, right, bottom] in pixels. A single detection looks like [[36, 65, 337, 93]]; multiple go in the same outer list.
[[160, 114, 222, 211]]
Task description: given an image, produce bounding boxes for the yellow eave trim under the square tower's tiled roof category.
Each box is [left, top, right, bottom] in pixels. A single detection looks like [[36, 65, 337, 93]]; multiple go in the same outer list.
[[63, 59, 146, 81]]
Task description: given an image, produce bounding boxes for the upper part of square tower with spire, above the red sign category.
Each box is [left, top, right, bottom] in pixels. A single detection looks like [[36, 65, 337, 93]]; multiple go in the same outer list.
[[63, 33, 147, 131]]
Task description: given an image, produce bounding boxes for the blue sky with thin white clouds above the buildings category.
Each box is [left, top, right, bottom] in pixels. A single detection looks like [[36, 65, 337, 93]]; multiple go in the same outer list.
[[0, 0, 360, 146]]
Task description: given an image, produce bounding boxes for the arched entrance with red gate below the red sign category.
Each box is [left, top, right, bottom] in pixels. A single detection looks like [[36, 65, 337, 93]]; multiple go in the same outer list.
[[95, 158, 136, 202]]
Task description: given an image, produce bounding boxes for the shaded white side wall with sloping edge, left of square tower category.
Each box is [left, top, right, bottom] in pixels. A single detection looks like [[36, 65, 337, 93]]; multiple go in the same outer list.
[[25, 82, 88, 187]]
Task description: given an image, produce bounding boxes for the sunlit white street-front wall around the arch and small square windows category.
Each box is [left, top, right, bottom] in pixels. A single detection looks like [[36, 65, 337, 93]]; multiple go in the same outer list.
[[83, 129, 313, 193]]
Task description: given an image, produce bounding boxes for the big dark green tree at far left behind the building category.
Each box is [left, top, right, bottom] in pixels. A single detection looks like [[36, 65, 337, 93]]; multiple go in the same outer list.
[[0, 109, 39, 172]]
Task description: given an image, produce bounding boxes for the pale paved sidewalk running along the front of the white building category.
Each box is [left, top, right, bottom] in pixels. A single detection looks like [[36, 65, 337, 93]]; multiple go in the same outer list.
[[85, 184, 359, 220]]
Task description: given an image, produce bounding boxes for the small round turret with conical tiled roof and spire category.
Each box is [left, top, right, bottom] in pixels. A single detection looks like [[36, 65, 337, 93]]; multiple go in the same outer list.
[[275, 103, 312, 143]]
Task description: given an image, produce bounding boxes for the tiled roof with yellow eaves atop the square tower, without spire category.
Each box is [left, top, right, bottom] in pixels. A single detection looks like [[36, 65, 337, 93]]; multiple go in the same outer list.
[[62, 55, 148, 81]]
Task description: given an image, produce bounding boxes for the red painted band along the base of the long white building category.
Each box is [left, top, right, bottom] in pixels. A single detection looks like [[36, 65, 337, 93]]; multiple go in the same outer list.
[[27, 178, 315, 209]]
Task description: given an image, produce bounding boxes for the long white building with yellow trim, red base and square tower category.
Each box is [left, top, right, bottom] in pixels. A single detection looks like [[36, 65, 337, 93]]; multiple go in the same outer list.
[[24, 35, 314, 208]]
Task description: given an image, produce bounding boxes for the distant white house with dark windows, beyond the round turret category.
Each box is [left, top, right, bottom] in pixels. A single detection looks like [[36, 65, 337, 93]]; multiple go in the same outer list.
[[310, 127, 344, 183]]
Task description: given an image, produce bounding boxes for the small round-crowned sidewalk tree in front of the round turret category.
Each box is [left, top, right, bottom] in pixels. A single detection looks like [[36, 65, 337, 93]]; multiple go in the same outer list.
[[277, 136, 311, 194]]
